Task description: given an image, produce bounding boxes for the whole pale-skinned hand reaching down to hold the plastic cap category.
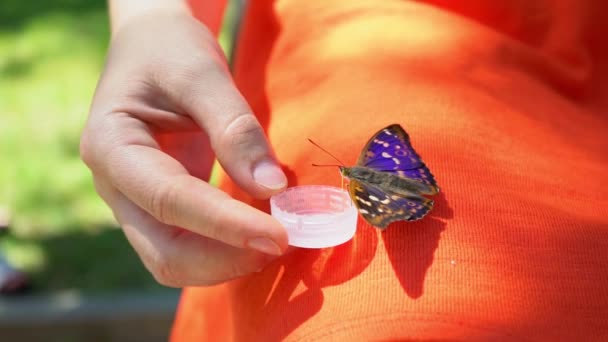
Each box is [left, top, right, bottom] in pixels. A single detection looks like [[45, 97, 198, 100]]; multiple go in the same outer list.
[[80, 0, 287, 287]]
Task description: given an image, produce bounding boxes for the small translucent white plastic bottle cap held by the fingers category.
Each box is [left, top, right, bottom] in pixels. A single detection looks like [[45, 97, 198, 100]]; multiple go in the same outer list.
[[270, 185, 358, 248]]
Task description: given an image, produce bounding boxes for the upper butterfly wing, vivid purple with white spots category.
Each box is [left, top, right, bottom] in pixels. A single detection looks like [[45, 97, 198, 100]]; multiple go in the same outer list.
[[357, 124, 439, 194]]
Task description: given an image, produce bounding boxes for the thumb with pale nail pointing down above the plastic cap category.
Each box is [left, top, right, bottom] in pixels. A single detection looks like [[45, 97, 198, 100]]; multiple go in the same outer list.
[[159, 62, 287, 198]]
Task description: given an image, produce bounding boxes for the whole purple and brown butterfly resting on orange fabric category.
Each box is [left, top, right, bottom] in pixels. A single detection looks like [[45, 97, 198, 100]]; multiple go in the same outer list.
[[311, 124, 439, 229]]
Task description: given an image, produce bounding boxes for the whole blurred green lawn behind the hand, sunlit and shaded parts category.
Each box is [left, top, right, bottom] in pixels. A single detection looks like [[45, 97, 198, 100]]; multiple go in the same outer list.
[[0, 0, 235, 293]]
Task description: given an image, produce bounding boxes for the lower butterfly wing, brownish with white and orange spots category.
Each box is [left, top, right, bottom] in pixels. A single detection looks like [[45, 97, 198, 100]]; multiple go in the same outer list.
[[348, 180, 433, 229]]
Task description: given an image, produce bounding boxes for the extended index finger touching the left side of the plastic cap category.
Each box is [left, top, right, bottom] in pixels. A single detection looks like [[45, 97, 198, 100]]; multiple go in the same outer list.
[[90, 115, 287, 255]]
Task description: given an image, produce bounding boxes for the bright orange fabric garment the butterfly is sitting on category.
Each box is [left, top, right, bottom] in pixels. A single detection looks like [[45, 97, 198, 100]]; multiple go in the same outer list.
[[172, 0, 608, 341]]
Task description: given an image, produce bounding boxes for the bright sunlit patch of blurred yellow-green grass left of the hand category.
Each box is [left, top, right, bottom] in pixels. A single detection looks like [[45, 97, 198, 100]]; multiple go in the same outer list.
[[0, 0, 111, 237]]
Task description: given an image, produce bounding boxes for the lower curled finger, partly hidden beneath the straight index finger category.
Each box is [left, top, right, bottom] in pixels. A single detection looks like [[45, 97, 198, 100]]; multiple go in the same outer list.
[[96, 178, 272, 287]]
